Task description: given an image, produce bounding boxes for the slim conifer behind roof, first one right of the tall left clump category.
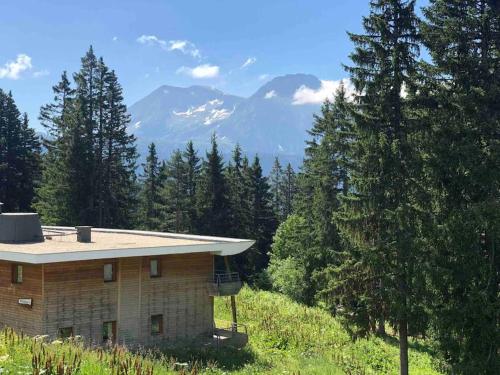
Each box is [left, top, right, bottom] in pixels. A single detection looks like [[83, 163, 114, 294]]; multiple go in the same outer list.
[[138, 143, 162, 231]]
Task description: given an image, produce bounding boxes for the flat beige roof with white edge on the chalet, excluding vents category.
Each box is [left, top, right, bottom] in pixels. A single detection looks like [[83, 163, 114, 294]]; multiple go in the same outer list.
[[0, 226, 254, 264]]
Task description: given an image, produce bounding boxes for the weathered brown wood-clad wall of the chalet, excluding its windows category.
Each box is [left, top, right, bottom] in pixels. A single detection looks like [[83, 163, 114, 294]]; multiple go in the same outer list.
[[0, 252, 214, 346]]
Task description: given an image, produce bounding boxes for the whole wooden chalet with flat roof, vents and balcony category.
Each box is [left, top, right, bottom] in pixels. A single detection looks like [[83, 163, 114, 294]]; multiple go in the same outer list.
[[0, 210, 253, 346]]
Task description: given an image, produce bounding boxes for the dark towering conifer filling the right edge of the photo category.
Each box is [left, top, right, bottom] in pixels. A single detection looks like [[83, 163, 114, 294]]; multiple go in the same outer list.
[[419, 0, 500, 374]]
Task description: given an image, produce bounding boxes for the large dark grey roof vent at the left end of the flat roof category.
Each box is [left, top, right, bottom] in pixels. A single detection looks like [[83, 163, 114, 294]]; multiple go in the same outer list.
[[0, 213, 43, 243]]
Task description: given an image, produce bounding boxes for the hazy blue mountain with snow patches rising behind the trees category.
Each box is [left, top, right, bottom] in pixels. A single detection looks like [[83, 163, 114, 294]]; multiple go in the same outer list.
[[129, 74, 321, 169]]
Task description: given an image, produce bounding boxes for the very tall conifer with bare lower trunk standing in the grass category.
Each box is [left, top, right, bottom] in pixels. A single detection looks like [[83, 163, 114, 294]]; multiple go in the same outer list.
[[337, 0, 426, 375]]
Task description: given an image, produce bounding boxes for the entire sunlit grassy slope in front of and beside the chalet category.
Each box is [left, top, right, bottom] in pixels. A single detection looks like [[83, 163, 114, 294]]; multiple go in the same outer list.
[[0, 288, 438, 375]]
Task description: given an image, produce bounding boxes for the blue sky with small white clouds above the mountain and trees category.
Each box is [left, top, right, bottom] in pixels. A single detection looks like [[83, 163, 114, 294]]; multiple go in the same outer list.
[[0, 0, 424, 130]]
